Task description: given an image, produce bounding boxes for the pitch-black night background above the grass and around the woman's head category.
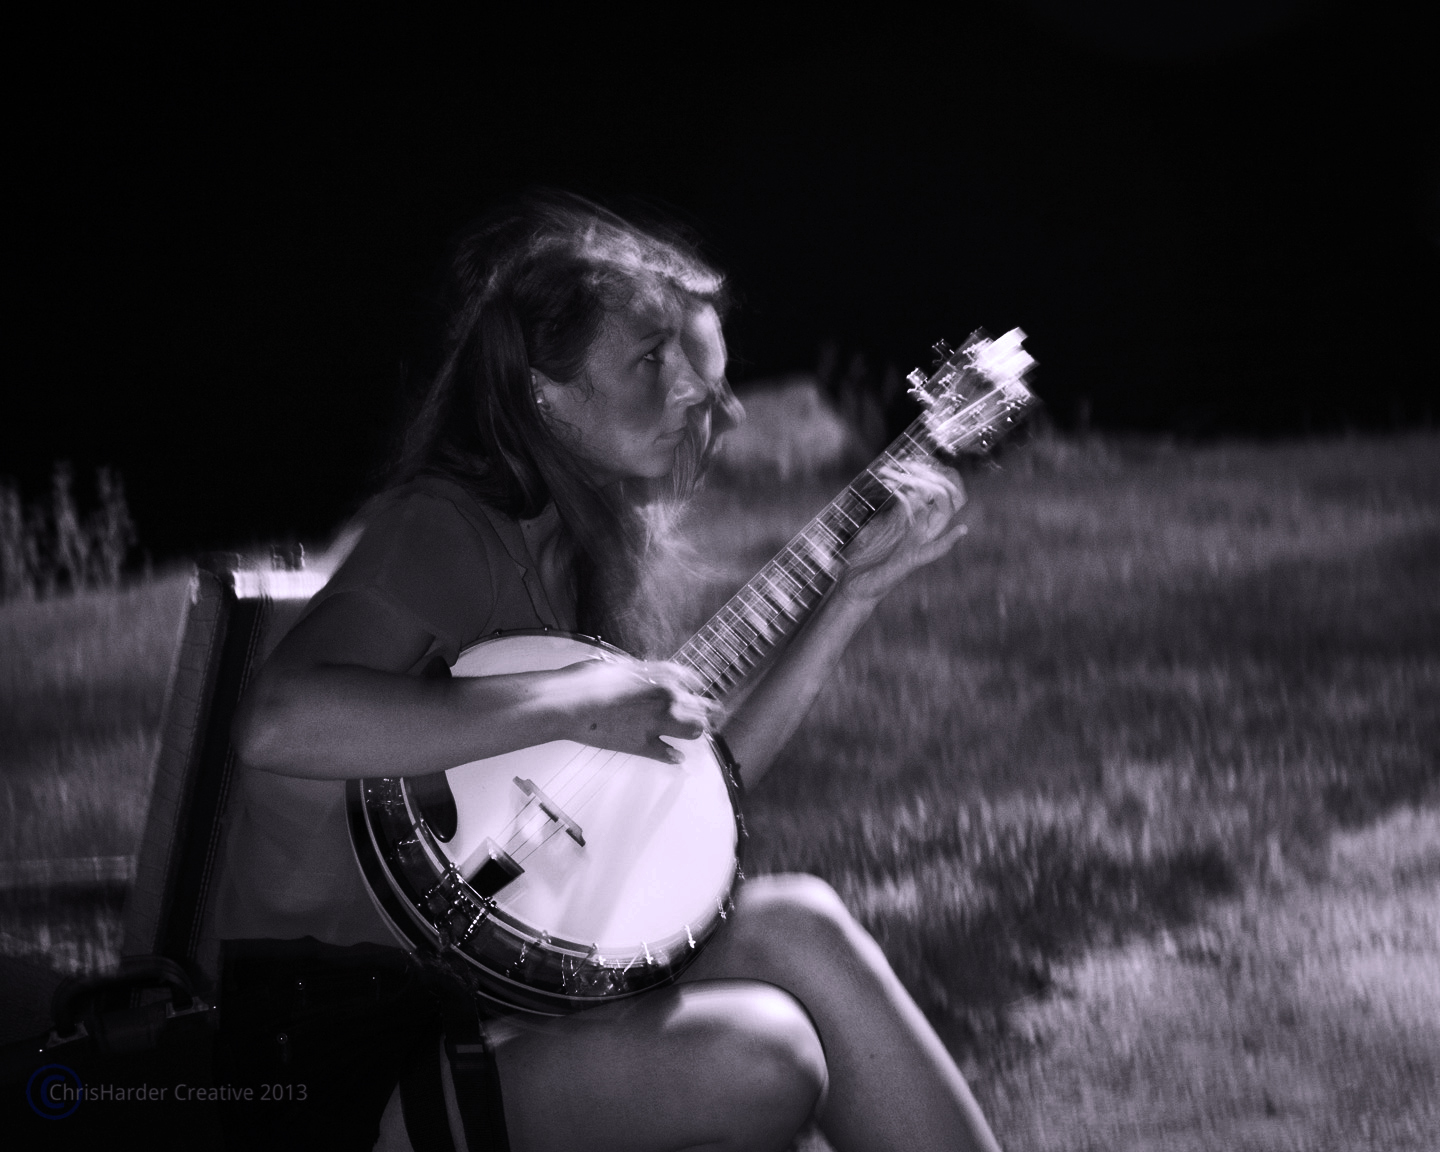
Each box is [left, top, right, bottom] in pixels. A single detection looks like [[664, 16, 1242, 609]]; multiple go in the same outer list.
[[0, 0, 1440, 559]]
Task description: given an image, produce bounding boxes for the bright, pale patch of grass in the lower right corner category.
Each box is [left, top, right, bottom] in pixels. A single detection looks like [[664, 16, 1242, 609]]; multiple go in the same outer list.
[[981, 806, 1440, 1152]]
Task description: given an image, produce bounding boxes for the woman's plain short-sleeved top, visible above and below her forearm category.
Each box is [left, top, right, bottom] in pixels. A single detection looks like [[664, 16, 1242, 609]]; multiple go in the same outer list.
[[215, 477, 576, 946]]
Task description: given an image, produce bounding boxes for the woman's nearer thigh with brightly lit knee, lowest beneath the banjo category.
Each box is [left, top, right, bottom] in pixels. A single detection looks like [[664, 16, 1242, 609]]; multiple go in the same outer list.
[[495, 981, 825, 1152]]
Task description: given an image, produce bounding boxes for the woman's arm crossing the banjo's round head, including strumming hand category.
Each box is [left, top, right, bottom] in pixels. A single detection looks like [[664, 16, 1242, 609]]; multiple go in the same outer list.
[[235, 592, 708, 779]]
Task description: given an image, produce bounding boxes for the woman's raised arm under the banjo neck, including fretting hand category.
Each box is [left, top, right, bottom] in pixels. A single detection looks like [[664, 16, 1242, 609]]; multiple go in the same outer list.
[[723, 467, 965, 785]]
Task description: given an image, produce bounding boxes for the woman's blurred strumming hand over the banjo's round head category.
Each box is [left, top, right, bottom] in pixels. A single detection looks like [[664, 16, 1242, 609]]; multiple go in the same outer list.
[[547, 657, 719, 765]]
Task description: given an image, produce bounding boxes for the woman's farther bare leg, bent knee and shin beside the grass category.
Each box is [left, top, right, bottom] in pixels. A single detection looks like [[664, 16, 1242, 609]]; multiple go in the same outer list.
[[681, 876, 999, 1152]]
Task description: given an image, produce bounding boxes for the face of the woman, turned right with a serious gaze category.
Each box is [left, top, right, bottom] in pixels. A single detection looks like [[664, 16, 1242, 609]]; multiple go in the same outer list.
[[536, 294, 726, 485]]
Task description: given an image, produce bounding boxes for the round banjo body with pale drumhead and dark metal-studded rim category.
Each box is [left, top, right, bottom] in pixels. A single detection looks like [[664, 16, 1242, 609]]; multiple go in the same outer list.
[[350, 631, 743, 1012]]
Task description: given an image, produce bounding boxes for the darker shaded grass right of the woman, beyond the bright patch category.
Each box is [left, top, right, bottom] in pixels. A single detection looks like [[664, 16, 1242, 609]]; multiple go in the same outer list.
[[679, 436, 1440, 1045]]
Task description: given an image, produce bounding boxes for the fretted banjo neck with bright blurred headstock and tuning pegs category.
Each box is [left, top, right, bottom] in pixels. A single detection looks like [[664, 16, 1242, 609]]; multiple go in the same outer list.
[[671, 328, 1035, 701]]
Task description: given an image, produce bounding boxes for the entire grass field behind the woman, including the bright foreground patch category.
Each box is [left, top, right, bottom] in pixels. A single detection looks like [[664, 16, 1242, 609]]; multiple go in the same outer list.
[[0, 435, 1440, 1149]]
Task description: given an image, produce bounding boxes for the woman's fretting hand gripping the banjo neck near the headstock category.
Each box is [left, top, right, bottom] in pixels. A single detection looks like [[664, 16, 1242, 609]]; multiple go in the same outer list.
[[837, 464, 966, 603]]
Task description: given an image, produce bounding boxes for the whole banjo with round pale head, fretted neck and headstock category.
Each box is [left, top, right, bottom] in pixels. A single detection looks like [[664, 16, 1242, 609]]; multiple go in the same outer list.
[[347, 328, 1035, 1015]]
